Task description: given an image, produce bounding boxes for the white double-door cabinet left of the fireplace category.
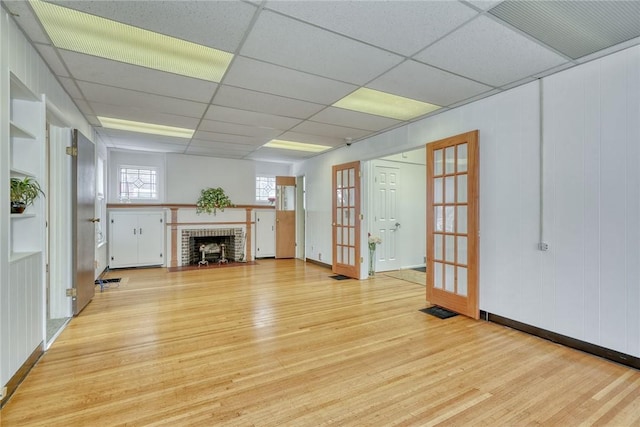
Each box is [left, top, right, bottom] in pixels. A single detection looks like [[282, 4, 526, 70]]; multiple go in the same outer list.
[[109, 210, 165, 268]]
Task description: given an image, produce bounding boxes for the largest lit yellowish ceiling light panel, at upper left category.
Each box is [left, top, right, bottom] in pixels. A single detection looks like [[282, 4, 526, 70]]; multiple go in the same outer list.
[[31, 1, 233, 82]]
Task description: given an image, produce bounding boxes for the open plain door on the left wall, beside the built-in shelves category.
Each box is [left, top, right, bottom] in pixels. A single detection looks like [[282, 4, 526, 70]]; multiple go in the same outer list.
[[72, 129, 96, 315]]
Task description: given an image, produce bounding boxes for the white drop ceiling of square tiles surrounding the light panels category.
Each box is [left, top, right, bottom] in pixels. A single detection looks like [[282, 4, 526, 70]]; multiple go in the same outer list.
[[2, 0, 640, 162]]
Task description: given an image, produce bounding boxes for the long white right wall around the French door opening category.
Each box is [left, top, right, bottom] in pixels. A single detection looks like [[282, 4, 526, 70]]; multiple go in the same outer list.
[[294, 46, 640, 357]]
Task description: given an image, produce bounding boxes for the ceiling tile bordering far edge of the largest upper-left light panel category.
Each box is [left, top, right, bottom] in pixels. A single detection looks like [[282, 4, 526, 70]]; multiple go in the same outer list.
[[60, 50, 217, 103]]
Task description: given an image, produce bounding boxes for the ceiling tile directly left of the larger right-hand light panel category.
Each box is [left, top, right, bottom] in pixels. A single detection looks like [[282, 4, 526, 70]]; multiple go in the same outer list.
[[213, 85, 324, 119]]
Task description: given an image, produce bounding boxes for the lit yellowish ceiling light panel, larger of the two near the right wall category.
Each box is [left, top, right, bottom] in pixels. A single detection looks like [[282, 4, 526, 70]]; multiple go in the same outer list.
[[333, 87, 441, 120]]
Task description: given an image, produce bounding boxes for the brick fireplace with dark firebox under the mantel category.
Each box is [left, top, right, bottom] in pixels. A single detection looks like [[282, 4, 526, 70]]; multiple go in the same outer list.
[[181, 228, 244, 266]]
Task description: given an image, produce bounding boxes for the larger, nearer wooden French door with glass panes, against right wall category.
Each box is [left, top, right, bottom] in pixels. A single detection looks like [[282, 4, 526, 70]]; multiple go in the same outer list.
[[427, 130, 480, 319]]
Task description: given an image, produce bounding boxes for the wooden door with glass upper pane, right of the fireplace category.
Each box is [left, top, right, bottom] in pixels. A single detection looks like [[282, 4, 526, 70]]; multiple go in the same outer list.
[[276, 176, 296, 258]]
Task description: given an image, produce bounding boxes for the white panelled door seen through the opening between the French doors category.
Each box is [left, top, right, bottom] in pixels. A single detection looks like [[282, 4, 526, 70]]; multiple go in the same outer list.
[[372, 166, 402, 271]]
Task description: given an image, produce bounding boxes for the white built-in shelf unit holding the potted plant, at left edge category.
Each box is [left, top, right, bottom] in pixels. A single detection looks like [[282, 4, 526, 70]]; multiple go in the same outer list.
[[0, 73, 47, 397]]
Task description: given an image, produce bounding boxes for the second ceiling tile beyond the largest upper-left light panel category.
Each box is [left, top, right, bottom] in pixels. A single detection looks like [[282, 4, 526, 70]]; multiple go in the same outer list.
[[77, 82, 207, 118]]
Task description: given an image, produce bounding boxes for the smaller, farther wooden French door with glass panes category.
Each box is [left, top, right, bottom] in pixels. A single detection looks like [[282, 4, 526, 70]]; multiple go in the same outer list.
[[332, 162, 360, 279]]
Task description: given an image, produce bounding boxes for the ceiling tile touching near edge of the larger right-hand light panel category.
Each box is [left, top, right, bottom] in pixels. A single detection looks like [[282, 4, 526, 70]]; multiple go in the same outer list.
[[367, 60, 492, 106]]
